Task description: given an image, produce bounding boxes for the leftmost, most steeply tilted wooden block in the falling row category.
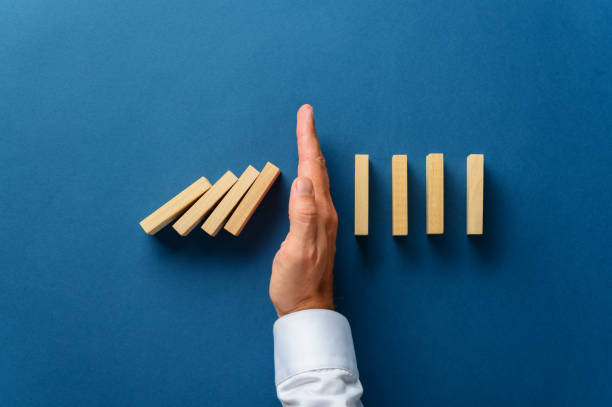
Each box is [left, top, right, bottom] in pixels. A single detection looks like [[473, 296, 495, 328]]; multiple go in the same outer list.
[[140, 177, 210, 235]]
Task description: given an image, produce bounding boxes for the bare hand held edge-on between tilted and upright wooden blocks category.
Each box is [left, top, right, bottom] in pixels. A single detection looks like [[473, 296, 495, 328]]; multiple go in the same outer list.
[[270, 105, 338, 317]]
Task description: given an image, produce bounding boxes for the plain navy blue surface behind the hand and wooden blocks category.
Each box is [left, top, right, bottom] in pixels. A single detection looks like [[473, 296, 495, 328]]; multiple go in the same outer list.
[[0, 0, 612, 406]]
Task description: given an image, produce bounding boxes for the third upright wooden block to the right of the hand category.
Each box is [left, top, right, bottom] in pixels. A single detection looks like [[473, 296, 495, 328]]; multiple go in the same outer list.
[[426, 154, 444, 235]]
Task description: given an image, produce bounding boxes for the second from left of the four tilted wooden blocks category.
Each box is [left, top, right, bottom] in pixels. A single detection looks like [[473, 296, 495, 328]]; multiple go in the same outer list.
[[172, 171, 238, 236]]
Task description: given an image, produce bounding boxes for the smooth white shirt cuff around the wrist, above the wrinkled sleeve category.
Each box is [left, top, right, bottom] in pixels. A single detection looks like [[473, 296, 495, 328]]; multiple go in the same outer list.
[[274, 309, 359, 385]]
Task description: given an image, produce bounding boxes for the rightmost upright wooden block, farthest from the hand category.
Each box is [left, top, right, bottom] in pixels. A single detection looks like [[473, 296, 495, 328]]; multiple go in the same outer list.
[[466, 154, 484, 235]]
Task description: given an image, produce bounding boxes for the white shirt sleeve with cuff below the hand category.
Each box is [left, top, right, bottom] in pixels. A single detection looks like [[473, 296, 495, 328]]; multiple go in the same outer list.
[[274, 309, 363, 407]]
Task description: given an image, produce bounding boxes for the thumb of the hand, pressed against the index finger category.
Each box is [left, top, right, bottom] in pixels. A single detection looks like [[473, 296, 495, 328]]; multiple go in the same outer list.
[[289, 177, 317, 242]]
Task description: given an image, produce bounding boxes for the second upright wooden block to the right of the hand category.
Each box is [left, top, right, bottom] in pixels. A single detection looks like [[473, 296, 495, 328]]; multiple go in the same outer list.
[[391, 155, 408, 236]]
